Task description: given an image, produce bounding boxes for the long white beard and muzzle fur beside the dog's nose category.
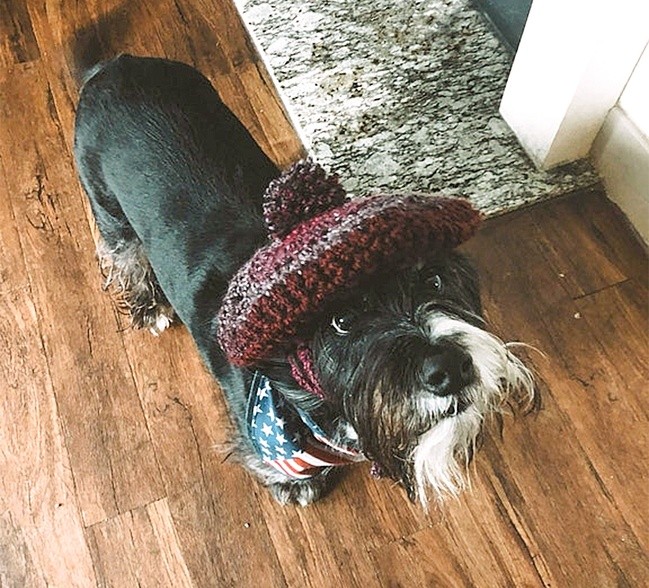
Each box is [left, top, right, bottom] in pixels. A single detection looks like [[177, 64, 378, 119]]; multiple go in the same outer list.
[[411, 314, 534, 507]]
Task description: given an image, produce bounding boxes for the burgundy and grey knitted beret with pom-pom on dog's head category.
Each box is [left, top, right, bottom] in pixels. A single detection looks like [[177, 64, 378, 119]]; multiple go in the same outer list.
[[217, 160, 481, 366]]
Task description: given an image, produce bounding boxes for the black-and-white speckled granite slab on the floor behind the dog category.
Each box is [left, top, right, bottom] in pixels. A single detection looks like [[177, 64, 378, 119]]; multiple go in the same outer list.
[[236, 0, 597, 214]]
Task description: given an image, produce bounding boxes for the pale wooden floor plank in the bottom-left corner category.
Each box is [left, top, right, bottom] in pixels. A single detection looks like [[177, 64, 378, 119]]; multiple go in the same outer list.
[[0, 289, 95, 587]]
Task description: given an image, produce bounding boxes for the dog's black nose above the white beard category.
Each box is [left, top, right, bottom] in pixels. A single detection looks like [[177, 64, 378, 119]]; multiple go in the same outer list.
[[423, 345, 474, 396]]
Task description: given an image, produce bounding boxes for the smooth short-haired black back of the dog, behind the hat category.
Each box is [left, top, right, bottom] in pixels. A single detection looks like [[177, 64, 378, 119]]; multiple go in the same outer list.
[[74, 55, 279, 354]]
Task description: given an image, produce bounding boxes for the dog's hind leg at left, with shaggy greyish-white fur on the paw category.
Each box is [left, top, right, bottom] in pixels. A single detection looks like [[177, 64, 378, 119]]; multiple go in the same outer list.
[[79, 161, 175, 335]]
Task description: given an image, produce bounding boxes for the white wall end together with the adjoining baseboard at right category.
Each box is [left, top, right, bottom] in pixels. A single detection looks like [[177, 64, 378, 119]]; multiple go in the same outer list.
[[500, 0, 649, 243]]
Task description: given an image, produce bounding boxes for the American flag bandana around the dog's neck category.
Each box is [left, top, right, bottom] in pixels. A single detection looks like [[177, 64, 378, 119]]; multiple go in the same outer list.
[[247, 372, 364, 479]]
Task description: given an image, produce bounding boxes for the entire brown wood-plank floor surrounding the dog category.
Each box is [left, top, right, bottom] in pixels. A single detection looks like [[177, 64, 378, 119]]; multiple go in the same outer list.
[[0, 0, 649, 588]]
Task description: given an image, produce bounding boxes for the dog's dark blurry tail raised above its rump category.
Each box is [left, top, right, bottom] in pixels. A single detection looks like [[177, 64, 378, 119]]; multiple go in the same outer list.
[[68, 2, 130, 88]]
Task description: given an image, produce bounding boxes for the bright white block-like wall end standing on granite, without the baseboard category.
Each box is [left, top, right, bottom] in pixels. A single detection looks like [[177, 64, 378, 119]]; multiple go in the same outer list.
[[500, 0, 649, 169]]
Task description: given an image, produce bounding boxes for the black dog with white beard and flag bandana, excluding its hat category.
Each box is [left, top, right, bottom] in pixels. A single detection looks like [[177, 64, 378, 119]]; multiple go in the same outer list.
[[74, 55, 534, 505]]
